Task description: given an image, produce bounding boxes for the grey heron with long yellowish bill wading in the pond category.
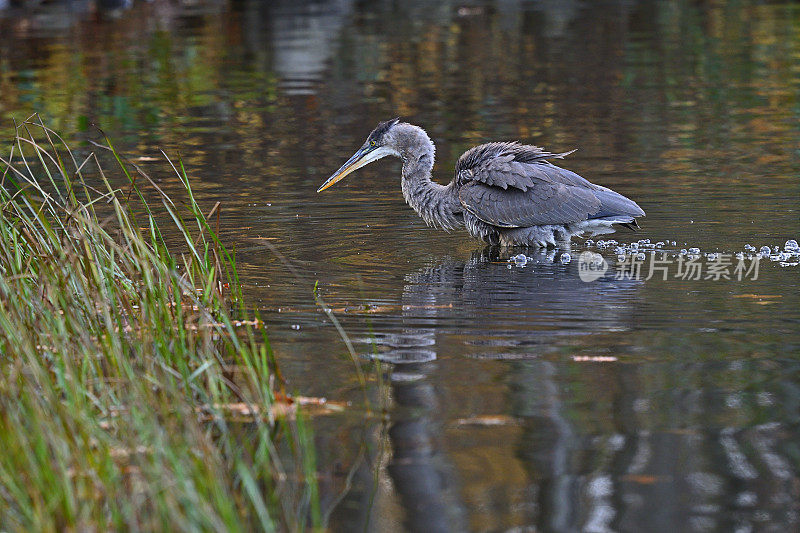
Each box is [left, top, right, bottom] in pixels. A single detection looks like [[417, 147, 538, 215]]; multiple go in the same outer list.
[[317, 119, 644, 247]]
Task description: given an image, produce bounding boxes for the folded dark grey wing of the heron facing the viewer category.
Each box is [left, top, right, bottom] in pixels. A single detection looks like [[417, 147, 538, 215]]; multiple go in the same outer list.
[[456, 143, 644, 228]]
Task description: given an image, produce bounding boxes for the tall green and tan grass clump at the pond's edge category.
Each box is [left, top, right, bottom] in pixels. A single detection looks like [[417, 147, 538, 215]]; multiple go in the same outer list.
[[0, 117, 319, 531]]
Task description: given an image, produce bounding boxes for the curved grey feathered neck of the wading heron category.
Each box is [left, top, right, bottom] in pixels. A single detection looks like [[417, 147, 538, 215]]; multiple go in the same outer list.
[[395, 124, 461, 230]]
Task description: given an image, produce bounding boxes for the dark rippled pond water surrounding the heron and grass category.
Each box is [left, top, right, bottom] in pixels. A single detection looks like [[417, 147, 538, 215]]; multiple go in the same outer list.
[[0, 0, 800, 531]]
